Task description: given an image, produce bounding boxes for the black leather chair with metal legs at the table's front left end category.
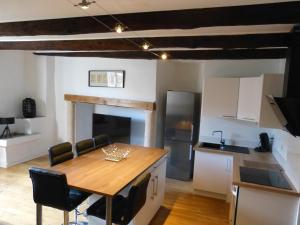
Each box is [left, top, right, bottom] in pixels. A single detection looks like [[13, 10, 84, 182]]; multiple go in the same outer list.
[[29, 167, 89, 225]]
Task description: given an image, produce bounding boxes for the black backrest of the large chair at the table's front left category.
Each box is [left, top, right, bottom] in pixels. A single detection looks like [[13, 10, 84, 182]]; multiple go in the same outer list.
[[29, 167, 70, 210]]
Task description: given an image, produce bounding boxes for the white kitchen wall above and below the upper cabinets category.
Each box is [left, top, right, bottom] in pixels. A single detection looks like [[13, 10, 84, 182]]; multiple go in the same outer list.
[[199, 59, 285, 147]]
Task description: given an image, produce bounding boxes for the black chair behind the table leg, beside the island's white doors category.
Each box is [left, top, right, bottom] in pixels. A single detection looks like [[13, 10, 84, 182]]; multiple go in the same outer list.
[[87, 174, 151, 225]]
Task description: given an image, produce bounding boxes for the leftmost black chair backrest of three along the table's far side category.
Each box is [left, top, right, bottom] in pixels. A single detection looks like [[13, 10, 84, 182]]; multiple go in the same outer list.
[[48, 142, 74, 166]]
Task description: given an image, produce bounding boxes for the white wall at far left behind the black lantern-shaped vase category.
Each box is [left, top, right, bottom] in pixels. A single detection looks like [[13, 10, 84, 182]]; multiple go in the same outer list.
[[0, 51, 56, 159]]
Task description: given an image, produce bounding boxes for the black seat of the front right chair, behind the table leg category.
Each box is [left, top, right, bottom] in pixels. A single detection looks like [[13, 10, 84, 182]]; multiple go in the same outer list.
[[87, 195, 130, 224]]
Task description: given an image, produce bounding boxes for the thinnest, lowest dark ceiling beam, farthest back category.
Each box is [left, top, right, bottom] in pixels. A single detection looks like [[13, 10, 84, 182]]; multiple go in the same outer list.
[[34, 48, 287, 60]]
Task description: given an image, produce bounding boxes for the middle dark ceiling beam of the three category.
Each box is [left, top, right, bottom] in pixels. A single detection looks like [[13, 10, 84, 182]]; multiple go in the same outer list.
[[0, 33, 300, 51]]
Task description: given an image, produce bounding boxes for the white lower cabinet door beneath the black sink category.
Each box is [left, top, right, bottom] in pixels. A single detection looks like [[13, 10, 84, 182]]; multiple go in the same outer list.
[[193, 151, 232, 195]]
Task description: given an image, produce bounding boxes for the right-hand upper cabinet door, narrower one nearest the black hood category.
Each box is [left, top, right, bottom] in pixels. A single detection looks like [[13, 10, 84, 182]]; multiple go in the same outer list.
[[237, 77, 263, 123]]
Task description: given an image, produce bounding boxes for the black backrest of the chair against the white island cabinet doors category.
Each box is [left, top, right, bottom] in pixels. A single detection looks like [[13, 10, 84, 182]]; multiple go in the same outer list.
[[127, 173, 151, 220]]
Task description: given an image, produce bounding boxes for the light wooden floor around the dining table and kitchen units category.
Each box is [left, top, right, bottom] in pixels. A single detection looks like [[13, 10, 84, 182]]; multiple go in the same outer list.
[[0, 157, 229, 225]]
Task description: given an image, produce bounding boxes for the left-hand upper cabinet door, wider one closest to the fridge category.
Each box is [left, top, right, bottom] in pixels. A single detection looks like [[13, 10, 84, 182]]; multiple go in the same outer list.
[[201, 77, 239, 118]]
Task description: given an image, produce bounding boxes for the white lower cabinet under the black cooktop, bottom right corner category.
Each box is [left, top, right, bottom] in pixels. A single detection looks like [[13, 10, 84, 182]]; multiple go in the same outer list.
[[235, 187, 299, 225]]
